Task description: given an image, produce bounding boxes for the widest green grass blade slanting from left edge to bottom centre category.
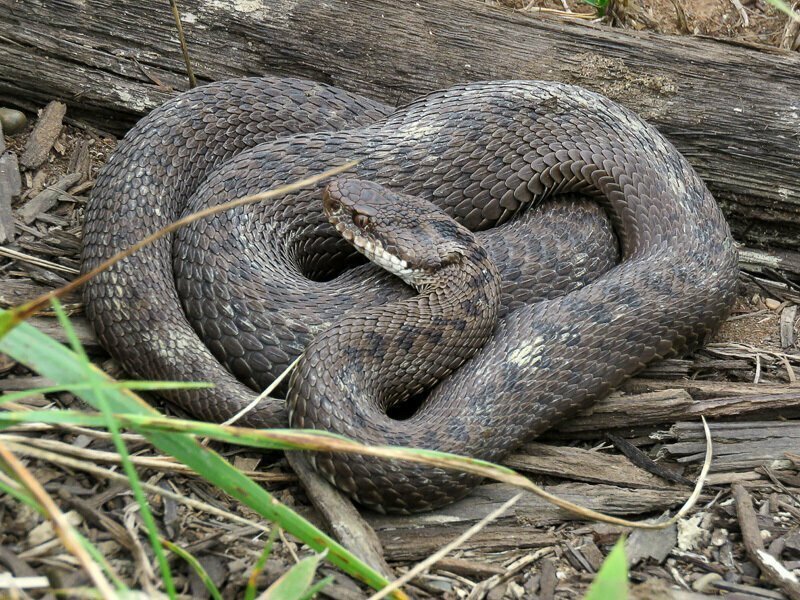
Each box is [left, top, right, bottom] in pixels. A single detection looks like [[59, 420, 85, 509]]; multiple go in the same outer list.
[[0, 311, 406, 598]]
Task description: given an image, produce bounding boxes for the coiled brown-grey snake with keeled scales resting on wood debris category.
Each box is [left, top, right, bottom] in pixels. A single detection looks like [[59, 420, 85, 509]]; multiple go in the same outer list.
[[82, 76, 737, 513]]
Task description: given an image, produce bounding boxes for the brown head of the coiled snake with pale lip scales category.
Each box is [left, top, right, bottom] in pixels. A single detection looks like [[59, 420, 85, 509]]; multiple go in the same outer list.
[[322, 177, 482, 289]]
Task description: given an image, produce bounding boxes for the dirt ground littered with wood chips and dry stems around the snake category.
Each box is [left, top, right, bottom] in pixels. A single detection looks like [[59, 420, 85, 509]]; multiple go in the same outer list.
[[0, 0, 800, 600]]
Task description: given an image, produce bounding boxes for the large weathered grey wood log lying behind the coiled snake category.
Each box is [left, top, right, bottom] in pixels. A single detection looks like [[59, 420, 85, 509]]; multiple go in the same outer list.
[[0, 0, 800, 248]]
